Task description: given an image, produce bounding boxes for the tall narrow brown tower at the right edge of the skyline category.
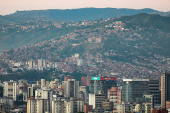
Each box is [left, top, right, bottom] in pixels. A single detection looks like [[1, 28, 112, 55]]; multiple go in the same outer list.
[[161, 71, 170, 109]]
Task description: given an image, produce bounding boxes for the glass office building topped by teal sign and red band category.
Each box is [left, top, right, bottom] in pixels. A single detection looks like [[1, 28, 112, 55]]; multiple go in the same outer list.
[[90, 77, 117, 97]]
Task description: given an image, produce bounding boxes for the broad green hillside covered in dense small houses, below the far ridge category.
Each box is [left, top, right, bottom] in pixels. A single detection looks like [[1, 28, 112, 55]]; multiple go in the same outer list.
[[0, 13, 170, 79]]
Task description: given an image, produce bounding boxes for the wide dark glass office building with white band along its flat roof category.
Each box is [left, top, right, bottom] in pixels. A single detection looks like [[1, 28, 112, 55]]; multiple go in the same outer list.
[[122, 79, 149, 103]]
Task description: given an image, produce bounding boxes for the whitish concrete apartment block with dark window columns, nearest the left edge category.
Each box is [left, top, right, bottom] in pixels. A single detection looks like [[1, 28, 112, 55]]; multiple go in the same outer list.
[[3, 80, 17, 101]]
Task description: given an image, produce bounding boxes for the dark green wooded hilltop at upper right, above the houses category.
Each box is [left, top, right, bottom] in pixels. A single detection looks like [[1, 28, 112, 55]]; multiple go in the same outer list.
[[119, 13, 170, 32]]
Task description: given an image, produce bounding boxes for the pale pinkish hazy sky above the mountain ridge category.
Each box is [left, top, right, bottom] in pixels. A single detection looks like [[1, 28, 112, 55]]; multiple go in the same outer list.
[[0, 0, 170, 15]]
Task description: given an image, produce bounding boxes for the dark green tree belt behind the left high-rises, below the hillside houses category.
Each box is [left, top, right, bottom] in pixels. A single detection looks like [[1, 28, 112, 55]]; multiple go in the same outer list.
[[0, 69, 87, 82]]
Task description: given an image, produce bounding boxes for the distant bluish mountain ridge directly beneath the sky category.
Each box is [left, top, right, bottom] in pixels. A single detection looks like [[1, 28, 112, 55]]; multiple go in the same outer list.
[[0, 8, 158, 24]]
